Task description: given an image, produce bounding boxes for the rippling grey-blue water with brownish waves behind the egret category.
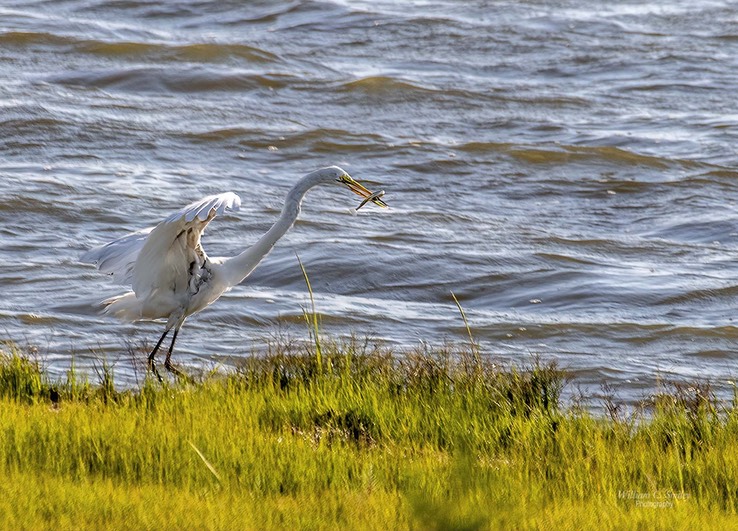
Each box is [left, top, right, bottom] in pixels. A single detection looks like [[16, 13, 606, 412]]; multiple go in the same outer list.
[[0, 0, 738, 398]]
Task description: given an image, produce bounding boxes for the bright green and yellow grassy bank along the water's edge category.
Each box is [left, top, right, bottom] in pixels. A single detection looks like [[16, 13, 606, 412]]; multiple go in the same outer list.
[[0, 338, 738, 529]]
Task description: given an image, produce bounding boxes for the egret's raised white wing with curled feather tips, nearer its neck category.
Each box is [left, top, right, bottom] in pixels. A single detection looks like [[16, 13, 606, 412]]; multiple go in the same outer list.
[[131, 192, 241, 299]]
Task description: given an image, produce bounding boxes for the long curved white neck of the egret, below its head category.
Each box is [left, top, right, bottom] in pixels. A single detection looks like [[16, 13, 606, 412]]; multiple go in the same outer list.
[[223, 173, 324, 286]]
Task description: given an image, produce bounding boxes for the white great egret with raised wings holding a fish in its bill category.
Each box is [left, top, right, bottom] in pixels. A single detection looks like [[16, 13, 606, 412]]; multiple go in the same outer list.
[[80, 166, 387, 380]]
